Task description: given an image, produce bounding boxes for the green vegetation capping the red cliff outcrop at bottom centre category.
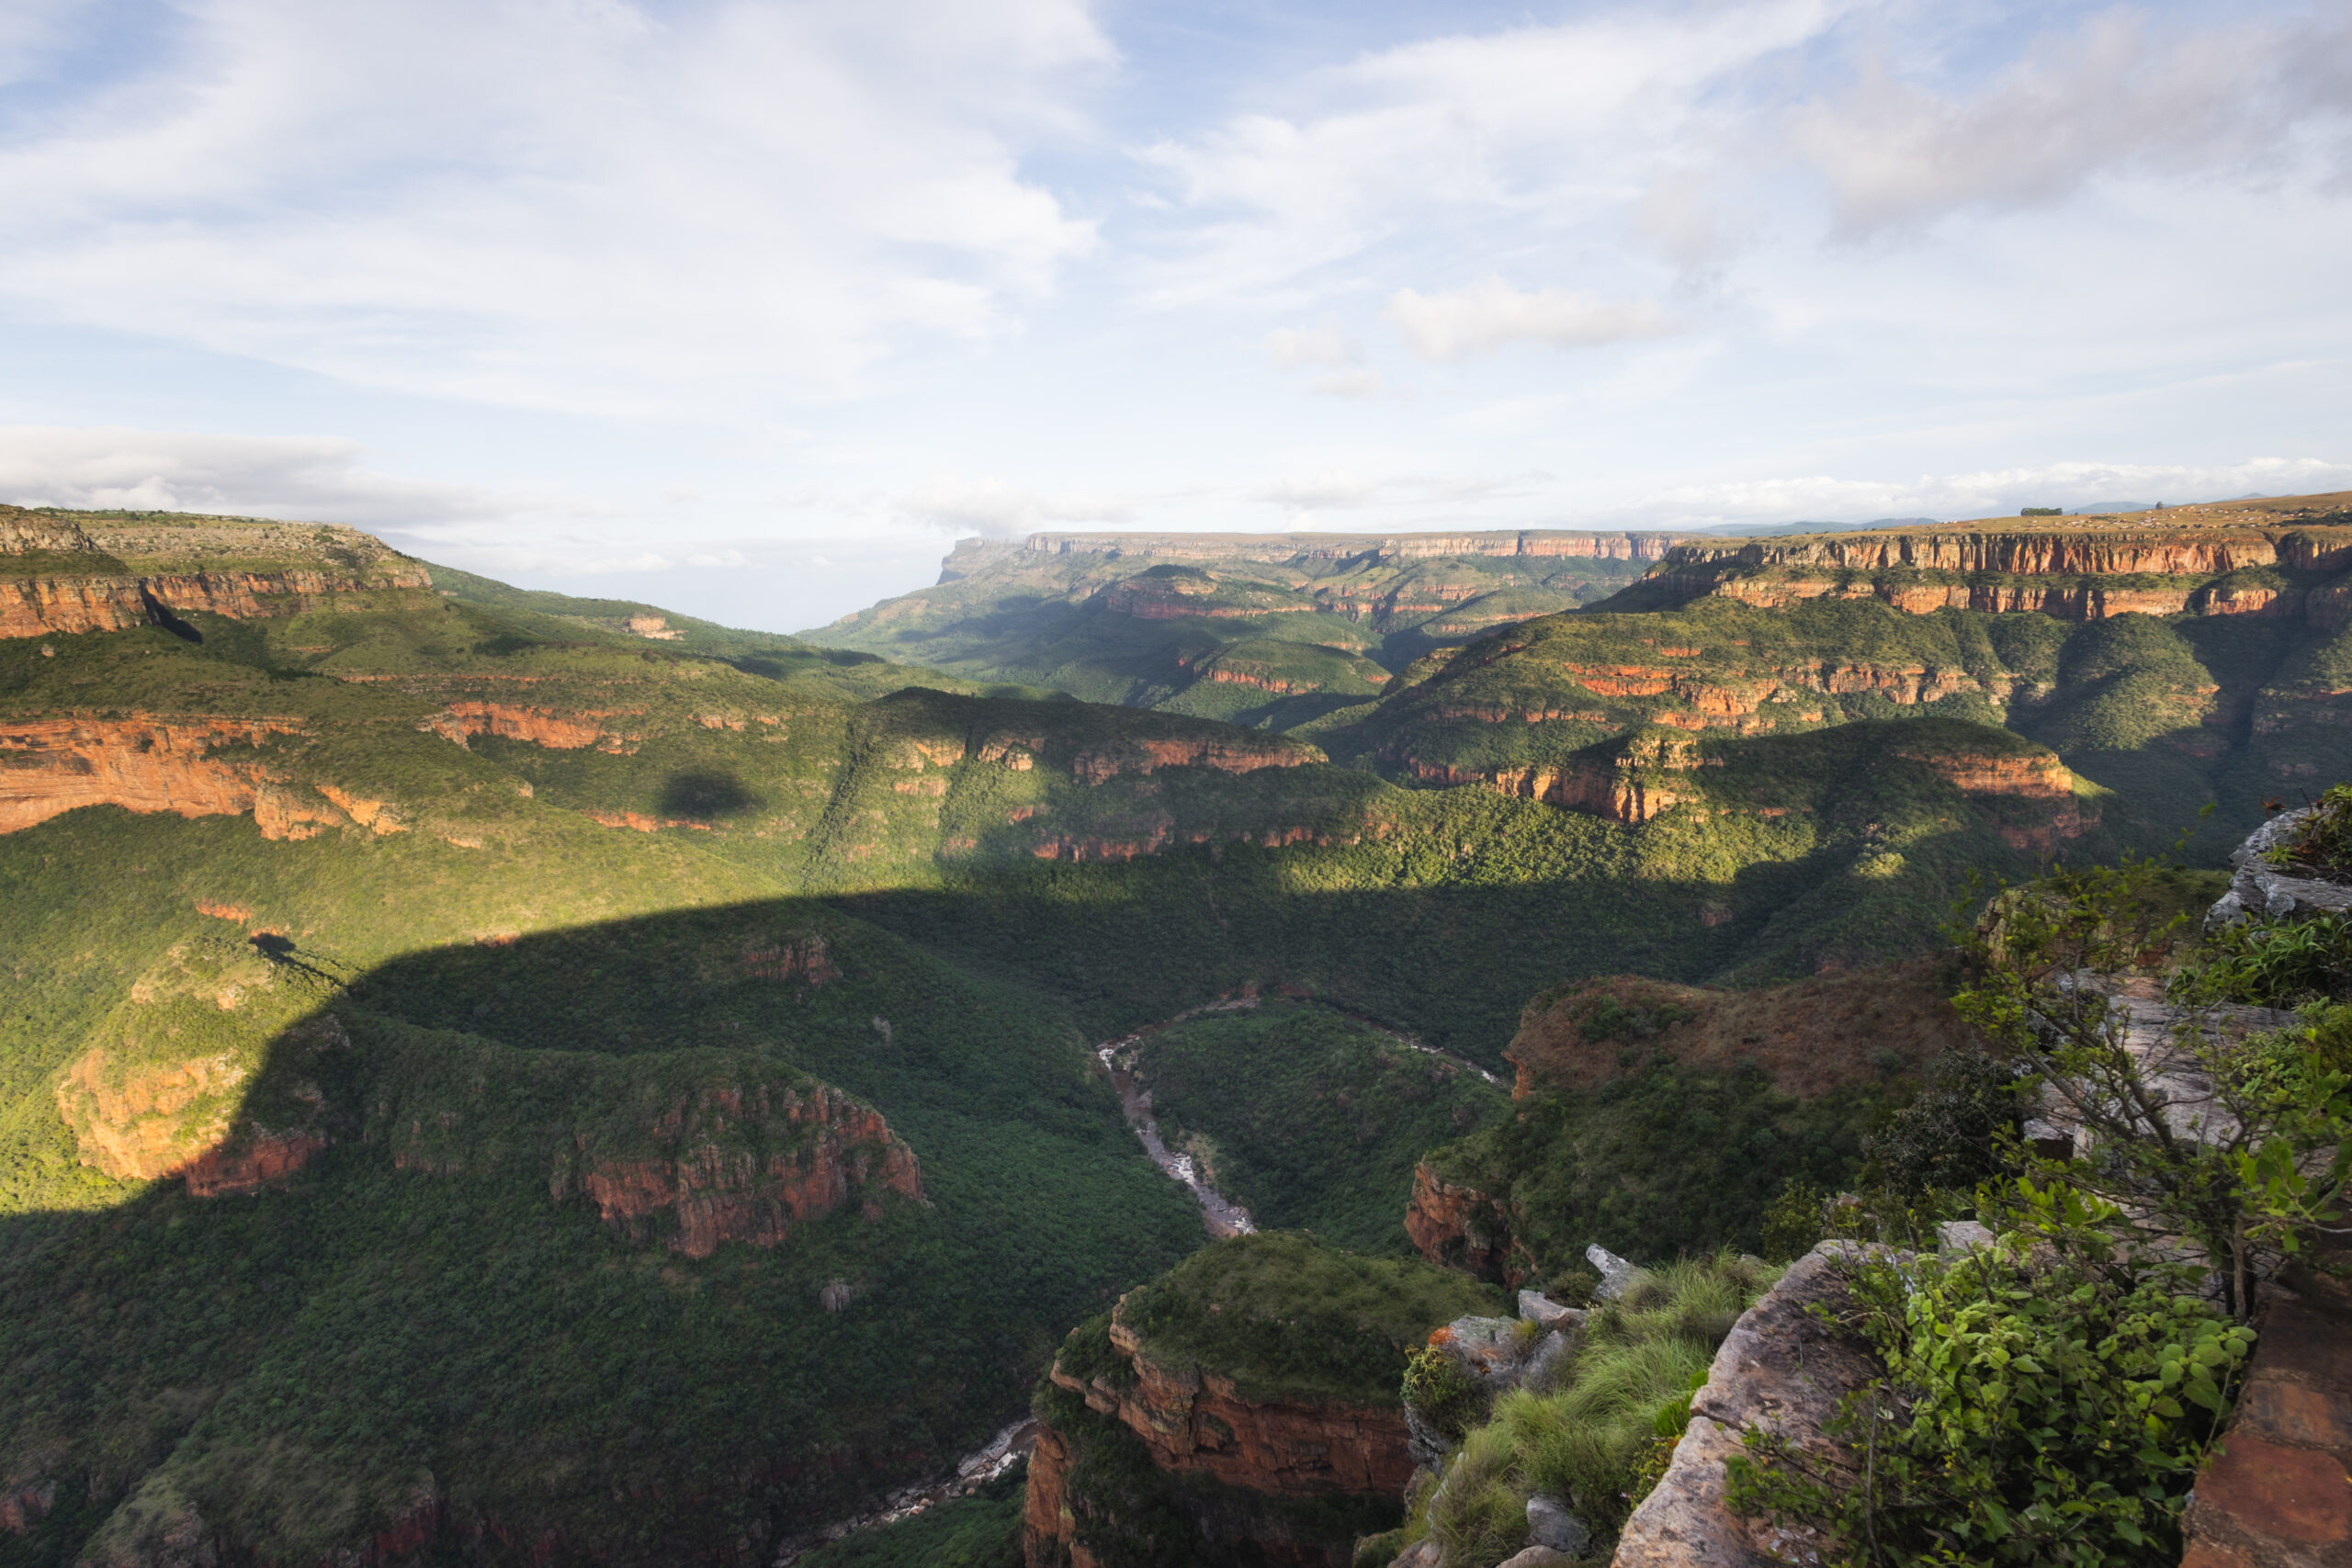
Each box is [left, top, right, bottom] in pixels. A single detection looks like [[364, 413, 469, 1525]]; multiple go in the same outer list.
[[1120, 1232, 1500, 1405]]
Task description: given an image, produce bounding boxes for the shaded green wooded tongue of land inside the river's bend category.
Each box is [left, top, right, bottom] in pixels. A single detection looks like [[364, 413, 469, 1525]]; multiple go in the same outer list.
[[1136, 1001, 1510, 1256]]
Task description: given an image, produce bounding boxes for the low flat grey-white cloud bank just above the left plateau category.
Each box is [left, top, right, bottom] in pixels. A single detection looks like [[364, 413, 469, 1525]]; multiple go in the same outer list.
[[0, 425, 492, 526]]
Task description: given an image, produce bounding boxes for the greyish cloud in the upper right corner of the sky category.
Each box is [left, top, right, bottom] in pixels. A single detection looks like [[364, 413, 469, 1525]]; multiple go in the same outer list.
[[1792, 9, 2352, 235]]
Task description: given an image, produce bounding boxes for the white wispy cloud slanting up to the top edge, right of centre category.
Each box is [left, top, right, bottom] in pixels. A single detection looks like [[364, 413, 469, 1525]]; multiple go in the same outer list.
[[1136, 0, 1856, 308]]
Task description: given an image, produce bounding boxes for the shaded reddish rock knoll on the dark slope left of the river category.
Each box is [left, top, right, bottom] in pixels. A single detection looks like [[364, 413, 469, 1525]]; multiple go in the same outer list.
[[545, 1081, 924, 1258]]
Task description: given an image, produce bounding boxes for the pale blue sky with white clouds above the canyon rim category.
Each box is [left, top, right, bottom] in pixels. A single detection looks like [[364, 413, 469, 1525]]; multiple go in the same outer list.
[[0, 0, 2352, 630]]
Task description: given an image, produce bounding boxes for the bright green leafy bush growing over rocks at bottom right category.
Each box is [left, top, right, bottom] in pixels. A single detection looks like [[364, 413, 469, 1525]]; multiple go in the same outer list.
[[1729, 1185, 2253, 1568]]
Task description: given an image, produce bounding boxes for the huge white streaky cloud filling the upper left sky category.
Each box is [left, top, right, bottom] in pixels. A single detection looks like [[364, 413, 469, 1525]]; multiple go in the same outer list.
[[0, 0, 1110, 413]]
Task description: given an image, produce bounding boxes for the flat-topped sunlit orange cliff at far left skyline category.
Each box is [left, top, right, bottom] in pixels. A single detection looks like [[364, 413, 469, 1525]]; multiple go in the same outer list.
[[0, 508, 433, 637]]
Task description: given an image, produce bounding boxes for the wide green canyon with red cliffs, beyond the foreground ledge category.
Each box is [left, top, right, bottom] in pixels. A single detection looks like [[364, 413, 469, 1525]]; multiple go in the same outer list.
[[0, 496, 2352, 1568]]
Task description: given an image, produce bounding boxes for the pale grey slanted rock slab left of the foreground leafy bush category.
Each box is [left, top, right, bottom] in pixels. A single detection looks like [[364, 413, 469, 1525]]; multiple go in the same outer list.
[[1611, 1241, 1884, 1568]]
